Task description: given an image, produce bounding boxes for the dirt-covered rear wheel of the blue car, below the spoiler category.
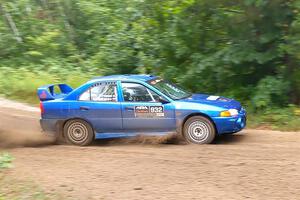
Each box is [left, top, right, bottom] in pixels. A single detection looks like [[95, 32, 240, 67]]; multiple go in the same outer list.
[[64, 119, 94, 146]]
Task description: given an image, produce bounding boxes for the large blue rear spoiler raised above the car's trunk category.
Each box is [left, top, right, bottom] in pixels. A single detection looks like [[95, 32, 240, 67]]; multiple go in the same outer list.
[[37, 84, 73, 101]]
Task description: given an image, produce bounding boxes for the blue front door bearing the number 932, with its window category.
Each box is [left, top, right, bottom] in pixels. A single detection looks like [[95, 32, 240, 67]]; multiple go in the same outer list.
[[121, 82, 176, 132]]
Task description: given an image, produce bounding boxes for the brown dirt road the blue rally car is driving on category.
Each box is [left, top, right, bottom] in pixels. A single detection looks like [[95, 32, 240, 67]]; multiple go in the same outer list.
[[0, 100, 300, 200]]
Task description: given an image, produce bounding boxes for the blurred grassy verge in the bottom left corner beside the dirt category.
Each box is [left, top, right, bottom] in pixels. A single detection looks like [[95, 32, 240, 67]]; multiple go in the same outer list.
[[0, 153, 62, 200]]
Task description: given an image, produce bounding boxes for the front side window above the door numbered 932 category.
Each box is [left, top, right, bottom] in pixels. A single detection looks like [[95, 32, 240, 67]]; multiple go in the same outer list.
[[122, 83, 159, 102]]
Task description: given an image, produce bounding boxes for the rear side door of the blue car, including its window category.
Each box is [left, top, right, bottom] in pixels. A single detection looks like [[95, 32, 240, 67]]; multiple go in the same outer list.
[[73, 82, 122, 133]]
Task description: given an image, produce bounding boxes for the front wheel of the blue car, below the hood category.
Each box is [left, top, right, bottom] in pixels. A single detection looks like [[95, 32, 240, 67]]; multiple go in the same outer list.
[[183, 116, 216, 144]]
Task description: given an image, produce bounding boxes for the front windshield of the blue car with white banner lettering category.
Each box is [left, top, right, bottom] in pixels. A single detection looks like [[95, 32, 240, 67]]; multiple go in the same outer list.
[[148, 79, 192, 100]]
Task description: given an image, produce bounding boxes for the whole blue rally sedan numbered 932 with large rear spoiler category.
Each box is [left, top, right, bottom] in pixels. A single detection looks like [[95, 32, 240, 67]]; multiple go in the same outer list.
[[38, 75, 246, 146]]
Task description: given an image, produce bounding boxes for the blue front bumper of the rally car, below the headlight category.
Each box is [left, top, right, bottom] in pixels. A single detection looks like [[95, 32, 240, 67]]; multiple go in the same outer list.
[[213, 113, 247, 135]]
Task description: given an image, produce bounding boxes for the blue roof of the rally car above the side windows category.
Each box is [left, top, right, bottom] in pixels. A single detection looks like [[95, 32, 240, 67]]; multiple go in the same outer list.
[[89, 74, 157, 82]]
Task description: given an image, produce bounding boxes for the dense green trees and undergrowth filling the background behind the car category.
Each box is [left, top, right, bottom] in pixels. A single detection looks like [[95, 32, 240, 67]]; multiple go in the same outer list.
[[0, 0, 300, 128]]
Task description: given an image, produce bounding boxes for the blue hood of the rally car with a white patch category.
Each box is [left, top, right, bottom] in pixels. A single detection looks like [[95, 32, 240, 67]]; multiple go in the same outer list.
[[181, 94, 242, 111]]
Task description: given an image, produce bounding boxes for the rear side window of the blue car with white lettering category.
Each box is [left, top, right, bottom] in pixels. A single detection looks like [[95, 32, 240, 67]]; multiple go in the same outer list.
[[79, 83, 117, 102]]
